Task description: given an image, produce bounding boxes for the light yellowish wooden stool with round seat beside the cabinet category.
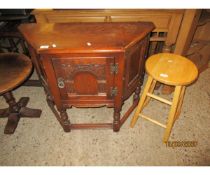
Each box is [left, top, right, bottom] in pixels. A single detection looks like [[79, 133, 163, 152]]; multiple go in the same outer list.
[[130, 53, 198, 143]]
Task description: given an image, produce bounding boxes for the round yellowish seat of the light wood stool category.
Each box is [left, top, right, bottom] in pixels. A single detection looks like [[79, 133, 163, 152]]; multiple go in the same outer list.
[[145, 53, 198, 86]]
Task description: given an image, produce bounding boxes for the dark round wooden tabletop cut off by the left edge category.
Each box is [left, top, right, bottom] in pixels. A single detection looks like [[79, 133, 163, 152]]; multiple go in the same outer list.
[[0, 53, 32, 94]]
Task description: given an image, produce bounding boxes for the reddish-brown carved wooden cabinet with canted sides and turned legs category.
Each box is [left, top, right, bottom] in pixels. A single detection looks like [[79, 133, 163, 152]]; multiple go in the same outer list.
[[19, 22, 154, 132]]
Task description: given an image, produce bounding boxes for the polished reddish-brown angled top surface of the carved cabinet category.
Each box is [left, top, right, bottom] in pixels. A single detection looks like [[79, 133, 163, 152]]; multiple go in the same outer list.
[[19, 22, 154, 53]]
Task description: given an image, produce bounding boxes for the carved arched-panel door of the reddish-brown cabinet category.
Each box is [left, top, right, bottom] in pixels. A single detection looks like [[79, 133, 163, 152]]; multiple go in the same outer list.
[[52, 57, 114, 106]]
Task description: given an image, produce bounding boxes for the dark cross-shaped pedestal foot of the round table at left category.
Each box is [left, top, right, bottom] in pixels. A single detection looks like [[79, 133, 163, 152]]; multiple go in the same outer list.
[[0, 92, 41, 134]]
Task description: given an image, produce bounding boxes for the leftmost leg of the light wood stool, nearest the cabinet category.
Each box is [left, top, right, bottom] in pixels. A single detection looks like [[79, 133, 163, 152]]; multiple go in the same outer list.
[[130, 76, 153, 128]]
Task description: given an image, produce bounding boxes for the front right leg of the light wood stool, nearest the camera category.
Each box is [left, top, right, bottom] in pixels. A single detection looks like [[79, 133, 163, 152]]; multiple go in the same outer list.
[[163, 86, 182, 143]]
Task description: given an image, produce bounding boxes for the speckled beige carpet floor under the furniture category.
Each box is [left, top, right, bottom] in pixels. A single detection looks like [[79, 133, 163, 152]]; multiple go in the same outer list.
[[0, 68, 210, 166]]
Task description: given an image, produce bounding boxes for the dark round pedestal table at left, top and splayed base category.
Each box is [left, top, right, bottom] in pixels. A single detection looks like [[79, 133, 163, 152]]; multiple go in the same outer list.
[[0, 53, 41, 134]]
